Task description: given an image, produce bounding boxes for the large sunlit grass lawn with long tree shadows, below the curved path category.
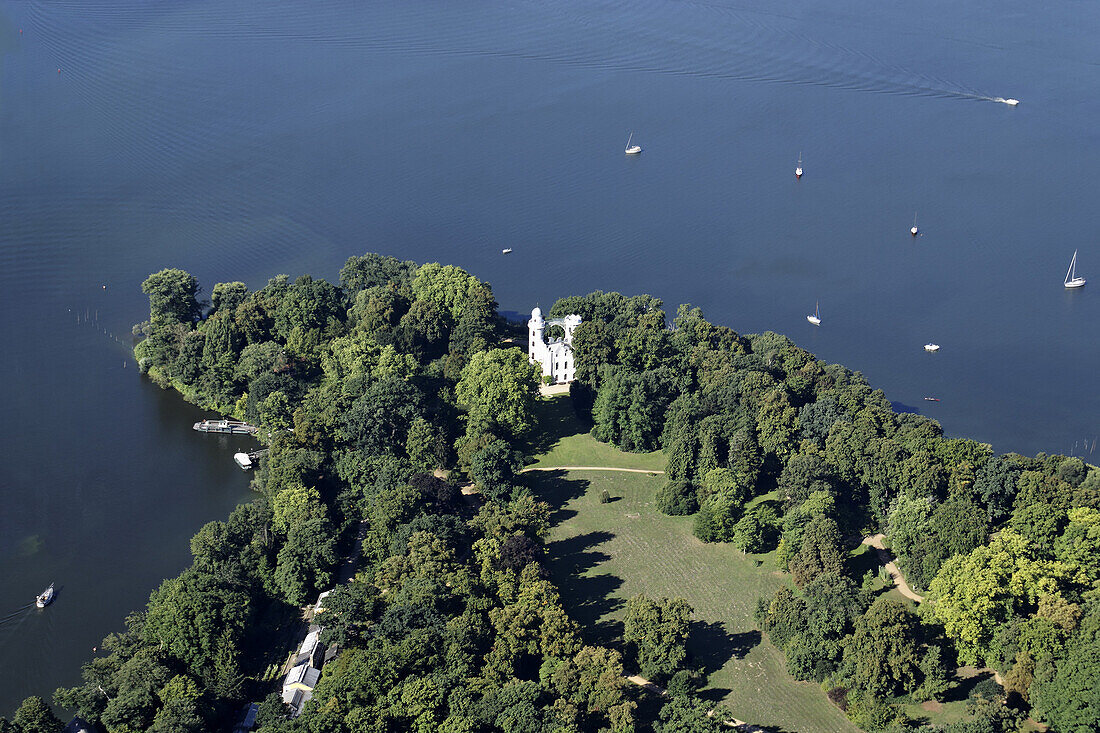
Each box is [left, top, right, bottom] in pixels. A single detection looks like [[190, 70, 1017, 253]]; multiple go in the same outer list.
[[525, 468, 858, 733]]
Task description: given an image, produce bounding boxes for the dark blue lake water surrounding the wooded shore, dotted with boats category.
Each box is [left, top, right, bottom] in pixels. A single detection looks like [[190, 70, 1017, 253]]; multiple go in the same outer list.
[[0, 0, 1100, 714]]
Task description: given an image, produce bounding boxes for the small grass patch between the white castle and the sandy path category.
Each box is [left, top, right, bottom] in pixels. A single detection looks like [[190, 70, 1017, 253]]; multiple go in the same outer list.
[[525, 394, 667, 471]]
